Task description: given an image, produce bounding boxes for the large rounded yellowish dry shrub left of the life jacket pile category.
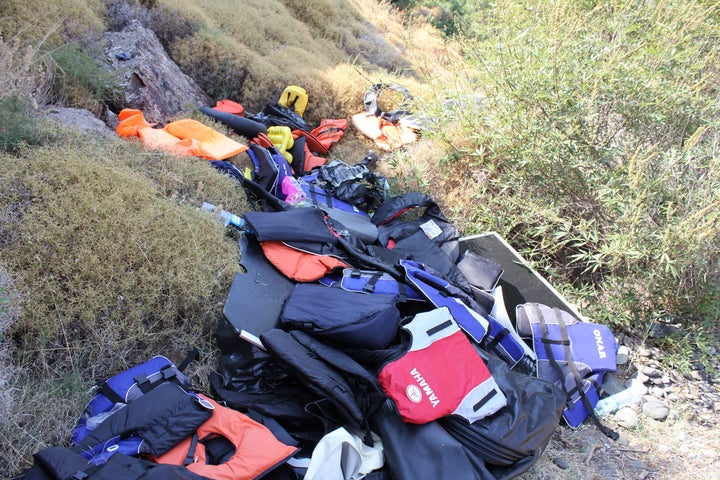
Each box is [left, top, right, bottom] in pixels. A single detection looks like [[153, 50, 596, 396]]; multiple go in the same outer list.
[[2, 139, 238, 371]]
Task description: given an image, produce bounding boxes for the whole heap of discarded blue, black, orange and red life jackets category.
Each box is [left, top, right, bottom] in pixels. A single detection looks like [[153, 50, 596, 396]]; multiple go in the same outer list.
[[25, 85, 617, 480]]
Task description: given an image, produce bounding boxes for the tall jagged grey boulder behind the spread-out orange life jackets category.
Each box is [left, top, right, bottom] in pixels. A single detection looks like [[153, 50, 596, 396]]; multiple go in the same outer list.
[[104, 20, 210, 123]]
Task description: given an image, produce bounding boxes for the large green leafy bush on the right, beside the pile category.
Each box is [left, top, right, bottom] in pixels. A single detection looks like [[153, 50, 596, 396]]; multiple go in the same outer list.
[[414, 0, 720, 330]]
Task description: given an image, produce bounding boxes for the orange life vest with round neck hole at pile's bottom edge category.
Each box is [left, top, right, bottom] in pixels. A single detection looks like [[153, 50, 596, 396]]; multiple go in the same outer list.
[[155, 394, 297, 480]]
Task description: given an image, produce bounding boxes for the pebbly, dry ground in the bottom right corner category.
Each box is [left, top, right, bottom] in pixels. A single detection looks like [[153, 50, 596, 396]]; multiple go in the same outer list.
[[522, 330, 720, 480]]
